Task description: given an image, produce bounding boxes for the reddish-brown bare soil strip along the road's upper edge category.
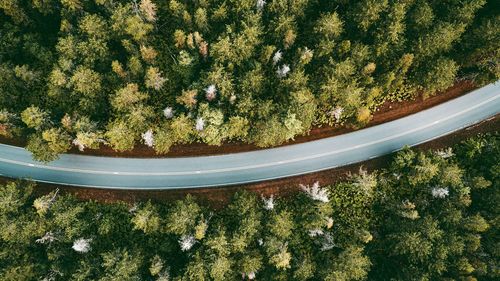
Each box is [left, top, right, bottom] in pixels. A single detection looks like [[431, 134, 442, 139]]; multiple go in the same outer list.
[[0, 81, 476, 158]]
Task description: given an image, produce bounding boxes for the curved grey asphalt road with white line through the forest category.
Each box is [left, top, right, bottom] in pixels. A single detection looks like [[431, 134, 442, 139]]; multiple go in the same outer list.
[[0, 81, 500, 189]]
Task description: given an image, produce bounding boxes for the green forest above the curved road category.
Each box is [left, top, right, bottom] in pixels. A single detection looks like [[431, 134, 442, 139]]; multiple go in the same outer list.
[[0, 0, 500, 161]]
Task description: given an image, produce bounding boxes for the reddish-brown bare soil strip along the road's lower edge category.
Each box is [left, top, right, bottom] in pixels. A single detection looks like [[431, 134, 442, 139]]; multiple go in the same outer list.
[[4, 110, 500, 208]]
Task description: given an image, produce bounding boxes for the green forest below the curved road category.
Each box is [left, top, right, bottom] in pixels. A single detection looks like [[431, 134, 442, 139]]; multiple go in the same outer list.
[[0, 133, 500, 281]]
